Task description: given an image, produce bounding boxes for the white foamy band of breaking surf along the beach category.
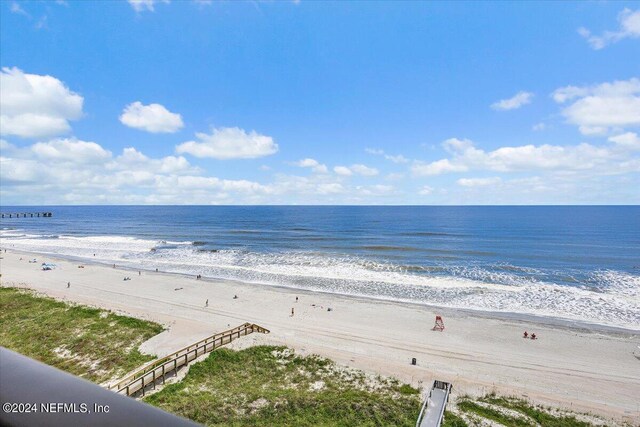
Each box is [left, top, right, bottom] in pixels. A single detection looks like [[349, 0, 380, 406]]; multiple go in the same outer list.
[[0, 229, 640, 329]]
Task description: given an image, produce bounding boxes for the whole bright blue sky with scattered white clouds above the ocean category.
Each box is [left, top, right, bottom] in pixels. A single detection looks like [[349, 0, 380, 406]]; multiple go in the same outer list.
[[0, 0, 640, 205]]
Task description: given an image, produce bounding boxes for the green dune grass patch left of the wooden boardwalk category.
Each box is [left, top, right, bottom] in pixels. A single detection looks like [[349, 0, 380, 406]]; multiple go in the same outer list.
[[0, 287, 163, 383]]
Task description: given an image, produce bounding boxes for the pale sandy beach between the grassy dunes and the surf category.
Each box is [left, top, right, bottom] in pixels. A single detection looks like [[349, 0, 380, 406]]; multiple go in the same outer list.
[[0, 251, 640, 424]]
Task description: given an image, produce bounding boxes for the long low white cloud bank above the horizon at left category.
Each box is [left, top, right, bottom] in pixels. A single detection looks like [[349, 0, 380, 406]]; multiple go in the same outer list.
[[0, 139, 274, 204]]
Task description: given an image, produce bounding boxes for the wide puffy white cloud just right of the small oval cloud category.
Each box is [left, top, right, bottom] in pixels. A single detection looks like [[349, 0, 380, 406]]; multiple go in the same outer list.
[[176, 127, 278, 160]]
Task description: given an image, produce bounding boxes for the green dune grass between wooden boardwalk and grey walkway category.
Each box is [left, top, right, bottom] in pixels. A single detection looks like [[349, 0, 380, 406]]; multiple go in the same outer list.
[[145, 346, 420, 426]]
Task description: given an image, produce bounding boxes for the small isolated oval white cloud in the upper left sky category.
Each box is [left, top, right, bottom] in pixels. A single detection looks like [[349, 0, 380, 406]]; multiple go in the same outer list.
[[120, 101, 184, 133]]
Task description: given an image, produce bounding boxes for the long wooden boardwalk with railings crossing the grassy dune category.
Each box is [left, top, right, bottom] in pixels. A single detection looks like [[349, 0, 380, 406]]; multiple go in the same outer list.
[[108, 323, 269, 396]]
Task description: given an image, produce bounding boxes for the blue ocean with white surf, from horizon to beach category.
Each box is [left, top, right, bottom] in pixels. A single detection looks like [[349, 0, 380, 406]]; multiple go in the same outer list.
[[0, 206, 640, 330]]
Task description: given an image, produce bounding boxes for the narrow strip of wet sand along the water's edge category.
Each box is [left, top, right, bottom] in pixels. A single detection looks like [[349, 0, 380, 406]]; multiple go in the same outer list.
[[3, 249, 640, 336]]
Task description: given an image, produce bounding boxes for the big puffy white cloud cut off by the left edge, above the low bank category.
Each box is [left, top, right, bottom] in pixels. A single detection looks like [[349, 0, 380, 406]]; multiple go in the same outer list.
[[0, 67, 84, 138]]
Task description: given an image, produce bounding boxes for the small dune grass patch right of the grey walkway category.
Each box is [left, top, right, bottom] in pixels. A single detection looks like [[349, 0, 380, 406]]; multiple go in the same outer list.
[[452, 394, 604, 427]]
